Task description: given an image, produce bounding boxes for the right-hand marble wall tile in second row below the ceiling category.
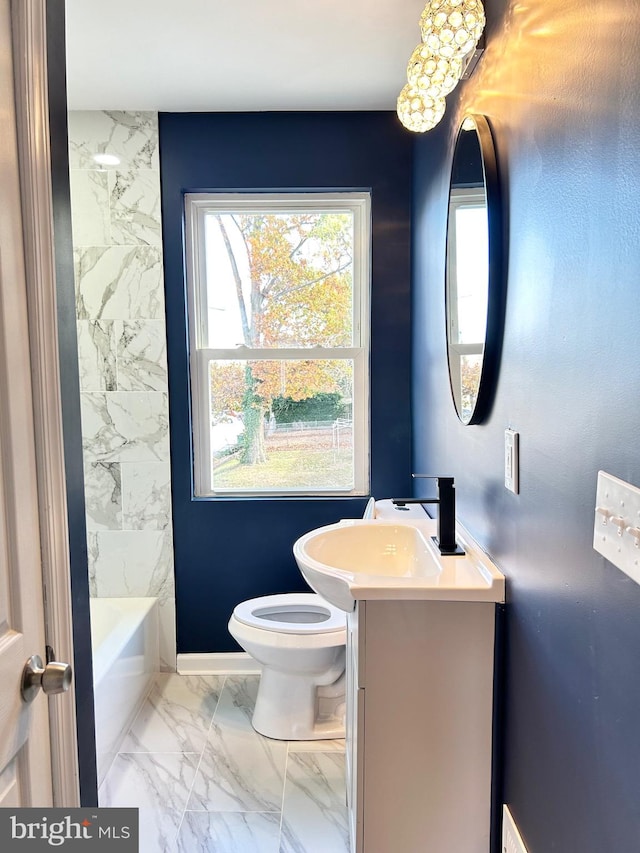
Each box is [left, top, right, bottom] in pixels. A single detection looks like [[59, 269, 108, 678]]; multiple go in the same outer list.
[[108, 170, 162, 246]]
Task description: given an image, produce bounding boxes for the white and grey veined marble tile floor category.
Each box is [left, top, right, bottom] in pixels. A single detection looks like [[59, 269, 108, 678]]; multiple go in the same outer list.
[[99, 673, 349, 853]]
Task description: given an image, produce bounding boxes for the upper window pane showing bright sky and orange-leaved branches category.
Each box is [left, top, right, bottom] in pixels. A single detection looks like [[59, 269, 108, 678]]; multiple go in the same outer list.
[[204, 211, 354, 349]]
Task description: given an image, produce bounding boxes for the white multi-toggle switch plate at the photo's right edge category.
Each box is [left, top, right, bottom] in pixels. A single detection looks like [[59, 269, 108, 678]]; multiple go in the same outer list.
[[593, 471, 640, 583]]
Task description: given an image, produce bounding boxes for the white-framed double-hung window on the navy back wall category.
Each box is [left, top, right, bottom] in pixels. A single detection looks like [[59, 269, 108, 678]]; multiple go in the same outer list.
[[185, 192, 370, 496]]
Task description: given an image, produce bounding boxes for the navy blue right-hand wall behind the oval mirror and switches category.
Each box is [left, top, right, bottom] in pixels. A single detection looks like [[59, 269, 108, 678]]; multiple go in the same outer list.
[[413, 0, 640, 853]]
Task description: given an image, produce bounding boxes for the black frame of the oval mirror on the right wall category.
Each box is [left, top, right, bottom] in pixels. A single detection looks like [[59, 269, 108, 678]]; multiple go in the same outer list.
[[445, 113, 506, 426]]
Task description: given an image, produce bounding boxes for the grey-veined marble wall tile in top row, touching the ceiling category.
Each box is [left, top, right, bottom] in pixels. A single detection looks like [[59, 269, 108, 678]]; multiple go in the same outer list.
[[69, 110, 160, 170]]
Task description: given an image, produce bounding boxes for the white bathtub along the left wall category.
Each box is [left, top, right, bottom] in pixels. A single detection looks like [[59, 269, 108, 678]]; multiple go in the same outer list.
[[90, 598, 160, 785]]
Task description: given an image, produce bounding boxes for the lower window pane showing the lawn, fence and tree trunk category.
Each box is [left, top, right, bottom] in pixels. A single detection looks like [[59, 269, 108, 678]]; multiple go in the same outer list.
[[209, 359, 354, 493]]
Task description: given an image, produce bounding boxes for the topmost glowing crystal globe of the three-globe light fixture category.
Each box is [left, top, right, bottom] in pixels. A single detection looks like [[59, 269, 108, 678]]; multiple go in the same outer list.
[[420, 0, 485, 59]]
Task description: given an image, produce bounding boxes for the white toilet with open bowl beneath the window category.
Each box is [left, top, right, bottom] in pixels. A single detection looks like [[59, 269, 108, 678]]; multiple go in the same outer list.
[[229, 593, 347, 740]]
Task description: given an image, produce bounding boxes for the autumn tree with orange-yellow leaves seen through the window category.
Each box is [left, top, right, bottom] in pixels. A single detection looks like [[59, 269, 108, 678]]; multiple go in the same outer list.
[[211, 212, 352, 464]]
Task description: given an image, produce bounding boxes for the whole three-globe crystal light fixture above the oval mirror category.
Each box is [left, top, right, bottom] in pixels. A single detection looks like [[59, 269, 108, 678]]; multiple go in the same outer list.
[[396, 0, 485, 133]]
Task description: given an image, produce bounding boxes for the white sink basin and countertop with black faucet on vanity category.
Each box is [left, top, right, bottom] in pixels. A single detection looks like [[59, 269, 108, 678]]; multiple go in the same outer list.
[[293, 518, 504, 612]]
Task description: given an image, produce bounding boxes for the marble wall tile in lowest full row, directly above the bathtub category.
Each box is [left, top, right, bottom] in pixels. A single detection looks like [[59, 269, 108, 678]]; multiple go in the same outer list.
[[90, 530, 175, 601]]
